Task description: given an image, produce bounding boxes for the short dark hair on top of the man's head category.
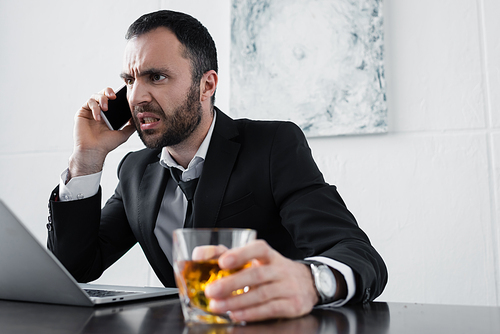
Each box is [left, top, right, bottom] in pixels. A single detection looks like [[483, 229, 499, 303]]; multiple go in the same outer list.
[[125, 10, 218, 104]]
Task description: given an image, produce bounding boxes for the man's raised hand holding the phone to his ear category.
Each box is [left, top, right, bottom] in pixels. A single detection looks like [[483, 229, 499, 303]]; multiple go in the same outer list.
[[67, 87, 135, 181]]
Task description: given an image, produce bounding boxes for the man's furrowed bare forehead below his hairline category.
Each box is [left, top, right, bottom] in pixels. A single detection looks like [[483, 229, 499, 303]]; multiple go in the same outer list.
[[123, 27, 191, 72]]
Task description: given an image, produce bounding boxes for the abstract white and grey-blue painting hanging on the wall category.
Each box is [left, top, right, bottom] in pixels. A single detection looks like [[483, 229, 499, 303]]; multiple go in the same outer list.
[[230, 0, 387, 137]]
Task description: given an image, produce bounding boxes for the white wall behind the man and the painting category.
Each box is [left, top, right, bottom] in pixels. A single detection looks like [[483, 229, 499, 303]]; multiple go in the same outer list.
[[0, 0, 500, 305]]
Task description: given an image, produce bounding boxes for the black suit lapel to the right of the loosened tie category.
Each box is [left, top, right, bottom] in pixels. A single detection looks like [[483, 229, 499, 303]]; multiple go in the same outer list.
[[193, 108, 240, 227]]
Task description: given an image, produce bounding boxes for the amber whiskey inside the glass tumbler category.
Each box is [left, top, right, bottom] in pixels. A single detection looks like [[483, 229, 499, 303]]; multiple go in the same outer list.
[[180, 259, 250, 313]]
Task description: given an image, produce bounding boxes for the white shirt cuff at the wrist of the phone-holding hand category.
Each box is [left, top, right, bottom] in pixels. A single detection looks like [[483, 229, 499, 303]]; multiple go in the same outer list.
[[59, 169, 102, 202]]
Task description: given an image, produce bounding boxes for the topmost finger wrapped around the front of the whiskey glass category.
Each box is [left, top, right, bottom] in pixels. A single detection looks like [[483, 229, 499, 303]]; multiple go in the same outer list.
[[219, 240, 279, 269]]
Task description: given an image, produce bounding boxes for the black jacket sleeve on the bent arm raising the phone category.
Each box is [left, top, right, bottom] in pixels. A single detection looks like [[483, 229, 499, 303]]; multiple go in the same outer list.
[[47, 159, 136, 282]]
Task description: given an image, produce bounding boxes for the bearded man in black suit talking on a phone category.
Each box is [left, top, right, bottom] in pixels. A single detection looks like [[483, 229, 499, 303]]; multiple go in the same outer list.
[[48, 11, 387, 321]]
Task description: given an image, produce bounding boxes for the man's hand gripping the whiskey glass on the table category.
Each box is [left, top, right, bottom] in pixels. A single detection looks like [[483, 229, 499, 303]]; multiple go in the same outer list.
[[205, 240, 318, 321]]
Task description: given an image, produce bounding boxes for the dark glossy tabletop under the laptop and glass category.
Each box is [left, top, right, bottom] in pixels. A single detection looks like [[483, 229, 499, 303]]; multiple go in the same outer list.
[[0, 297, 500, 334]]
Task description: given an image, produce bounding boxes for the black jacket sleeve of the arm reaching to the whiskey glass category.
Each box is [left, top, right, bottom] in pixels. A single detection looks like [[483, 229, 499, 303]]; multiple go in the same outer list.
[[269, 123, 387, 302]]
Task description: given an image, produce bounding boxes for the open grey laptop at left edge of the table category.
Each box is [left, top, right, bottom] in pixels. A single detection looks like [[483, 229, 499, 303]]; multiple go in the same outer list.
[[0, 200, 178, 306]]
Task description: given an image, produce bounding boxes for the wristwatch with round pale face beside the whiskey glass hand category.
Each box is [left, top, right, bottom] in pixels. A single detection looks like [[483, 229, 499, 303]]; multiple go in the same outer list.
[[298, 260, 337, 305]]
